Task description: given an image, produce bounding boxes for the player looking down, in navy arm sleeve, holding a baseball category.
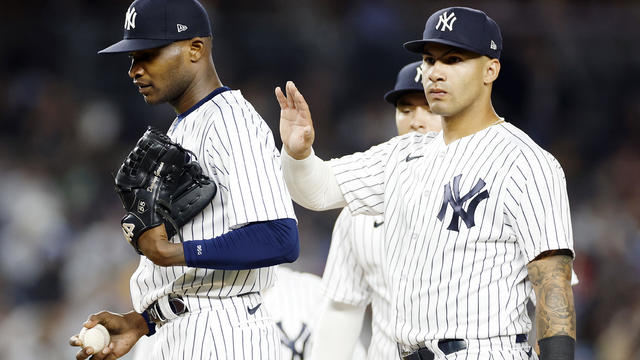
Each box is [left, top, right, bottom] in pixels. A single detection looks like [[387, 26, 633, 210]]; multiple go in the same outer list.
[[70, 0, 299, 360]]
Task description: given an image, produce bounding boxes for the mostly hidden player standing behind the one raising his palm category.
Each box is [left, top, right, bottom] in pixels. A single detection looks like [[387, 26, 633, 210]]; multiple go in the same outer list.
[[313, 61, 442, 360]]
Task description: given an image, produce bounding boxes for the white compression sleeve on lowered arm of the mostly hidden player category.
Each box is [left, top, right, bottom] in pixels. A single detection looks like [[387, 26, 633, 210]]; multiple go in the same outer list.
[[311, 297, 366, 360]]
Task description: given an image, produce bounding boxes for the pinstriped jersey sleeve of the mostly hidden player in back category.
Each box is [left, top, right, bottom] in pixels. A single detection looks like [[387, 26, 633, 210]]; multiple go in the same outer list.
[[322, 209, 371, 306]]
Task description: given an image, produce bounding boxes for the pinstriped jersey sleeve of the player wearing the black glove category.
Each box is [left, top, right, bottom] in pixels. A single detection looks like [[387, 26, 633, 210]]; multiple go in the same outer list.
[[208, 91, 295, 229]]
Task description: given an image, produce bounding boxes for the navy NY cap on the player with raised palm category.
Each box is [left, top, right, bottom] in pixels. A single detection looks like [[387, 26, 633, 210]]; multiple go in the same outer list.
[[404, 7, 502, 59]]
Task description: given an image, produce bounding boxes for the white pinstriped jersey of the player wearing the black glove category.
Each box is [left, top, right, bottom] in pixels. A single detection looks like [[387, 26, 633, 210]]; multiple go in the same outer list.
[[130, 90, 295, 312]]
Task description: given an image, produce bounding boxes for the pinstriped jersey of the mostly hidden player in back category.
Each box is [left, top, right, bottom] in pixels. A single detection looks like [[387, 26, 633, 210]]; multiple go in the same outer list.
[[322, 209, 398, 360]]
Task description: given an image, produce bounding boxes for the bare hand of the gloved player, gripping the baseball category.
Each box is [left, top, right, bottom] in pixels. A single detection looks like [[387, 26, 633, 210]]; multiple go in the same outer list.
[[69, 311, 149, 360]]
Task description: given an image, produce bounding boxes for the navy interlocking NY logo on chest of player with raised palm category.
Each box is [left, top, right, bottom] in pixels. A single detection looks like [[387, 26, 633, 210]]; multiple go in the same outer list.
[[438, 174, 489, 231]]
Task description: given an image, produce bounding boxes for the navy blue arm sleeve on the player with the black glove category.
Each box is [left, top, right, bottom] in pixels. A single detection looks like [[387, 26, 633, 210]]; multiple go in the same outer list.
[[182, 219, 300, 270]]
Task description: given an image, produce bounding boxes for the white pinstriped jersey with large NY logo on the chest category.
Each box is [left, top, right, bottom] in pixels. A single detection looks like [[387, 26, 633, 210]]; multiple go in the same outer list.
[[331, 123, 573, 345]]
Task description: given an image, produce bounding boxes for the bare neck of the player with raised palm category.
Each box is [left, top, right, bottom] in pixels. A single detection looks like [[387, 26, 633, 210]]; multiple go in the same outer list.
[[442, 102, 502, 145]]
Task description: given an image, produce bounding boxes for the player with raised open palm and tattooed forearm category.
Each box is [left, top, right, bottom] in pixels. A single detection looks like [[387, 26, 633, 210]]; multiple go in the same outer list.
[[276, 7, 576, 360]]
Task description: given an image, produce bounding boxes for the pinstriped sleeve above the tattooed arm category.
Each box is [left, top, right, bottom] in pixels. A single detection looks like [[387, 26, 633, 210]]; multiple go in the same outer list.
[[505, 151, 573, 261]]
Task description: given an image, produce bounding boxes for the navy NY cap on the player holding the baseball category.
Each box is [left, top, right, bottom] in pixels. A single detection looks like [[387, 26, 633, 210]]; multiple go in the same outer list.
[[98, 0, 211, 54]]
